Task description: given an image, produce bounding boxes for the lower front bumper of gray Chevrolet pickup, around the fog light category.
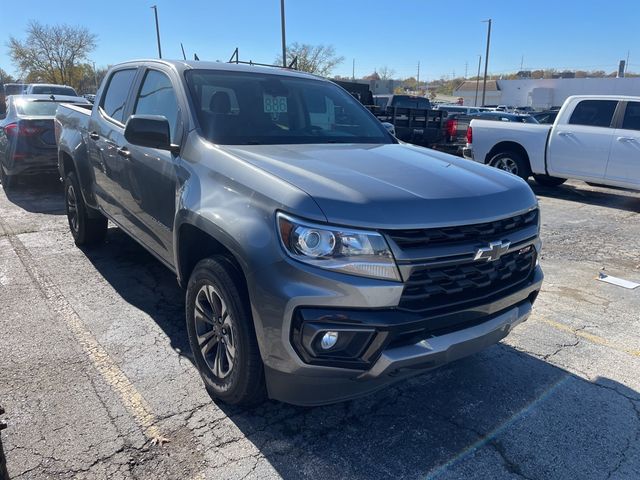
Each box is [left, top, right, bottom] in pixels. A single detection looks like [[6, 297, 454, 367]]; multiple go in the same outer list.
[[265, 267, 543, 406]]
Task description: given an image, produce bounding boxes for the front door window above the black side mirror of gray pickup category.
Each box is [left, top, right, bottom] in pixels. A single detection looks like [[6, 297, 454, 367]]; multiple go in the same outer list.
[[134, 70, 178, 140]]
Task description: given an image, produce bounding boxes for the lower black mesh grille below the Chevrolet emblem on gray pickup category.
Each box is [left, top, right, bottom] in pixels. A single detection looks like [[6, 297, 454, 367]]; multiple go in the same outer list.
[[399, 245, 536, 312]]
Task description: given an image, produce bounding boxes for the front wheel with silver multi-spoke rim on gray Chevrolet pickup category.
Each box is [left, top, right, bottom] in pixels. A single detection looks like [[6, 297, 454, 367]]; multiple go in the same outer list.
[[186, 256, 266, 406]]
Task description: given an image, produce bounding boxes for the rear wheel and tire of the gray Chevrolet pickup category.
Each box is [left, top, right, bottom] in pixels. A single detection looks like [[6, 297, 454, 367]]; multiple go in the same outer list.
[[64, 172, 108, 247]]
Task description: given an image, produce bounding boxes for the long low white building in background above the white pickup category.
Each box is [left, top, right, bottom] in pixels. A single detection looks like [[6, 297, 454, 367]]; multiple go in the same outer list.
[[454, 77, 640, 110]]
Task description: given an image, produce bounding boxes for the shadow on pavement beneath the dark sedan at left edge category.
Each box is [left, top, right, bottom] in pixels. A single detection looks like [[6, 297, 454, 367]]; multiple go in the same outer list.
[[4, 175, 65, 215]]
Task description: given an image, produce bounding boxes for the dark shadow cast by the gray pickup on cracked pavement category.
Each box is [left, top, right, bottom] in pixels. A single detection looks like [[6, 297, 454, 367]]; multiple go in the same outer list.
[[86, 228, 640, 480]]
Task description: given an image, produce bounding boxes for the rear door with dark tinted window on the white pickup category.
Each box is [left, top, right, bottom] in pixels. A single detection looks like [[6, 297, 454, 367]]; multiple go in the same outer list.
[[547, 99, 618, 180]]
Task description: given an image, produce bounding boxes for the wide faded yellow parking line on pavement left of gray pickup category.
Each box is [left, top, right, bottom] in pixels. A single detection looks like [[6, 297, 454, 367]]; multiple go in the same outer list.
[[0, 220, 168, 443]]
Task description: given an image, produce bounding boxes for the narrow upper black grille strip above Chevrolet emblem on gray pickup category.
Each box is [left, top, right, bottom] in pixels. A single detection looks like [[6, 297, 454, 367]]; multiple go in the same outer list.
[[387, 209, 538, 250]]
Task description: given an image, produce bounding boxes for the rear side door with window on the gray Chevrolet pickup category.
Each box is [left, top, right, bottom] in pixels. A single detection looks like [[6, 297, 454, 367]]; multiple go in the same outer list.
[[86, 68, 138, 229]]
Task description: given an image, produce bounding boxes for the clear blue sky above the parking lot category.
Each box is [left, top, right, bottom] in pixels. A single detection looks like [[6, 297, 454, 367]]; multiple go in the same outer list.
[[0, 0, 640, 80]]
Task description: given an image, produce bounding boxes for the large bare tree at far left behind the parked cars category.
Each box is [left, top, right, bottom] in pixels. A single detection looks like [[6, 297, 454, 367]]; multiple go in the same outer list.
[[8, 21, 97, 86]]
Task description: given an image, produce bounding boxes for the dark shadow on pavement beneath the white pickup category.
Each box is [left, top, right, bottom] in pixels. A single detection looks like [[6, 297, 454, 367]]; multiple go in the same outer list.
[[529, 180, 640, 213]]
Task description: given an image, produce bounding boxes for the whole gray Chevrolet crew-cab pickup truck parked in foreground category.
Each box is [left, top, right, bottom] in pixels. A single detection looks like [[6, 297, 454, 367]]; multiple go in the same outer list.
[[56, 60, 542, 405]]
